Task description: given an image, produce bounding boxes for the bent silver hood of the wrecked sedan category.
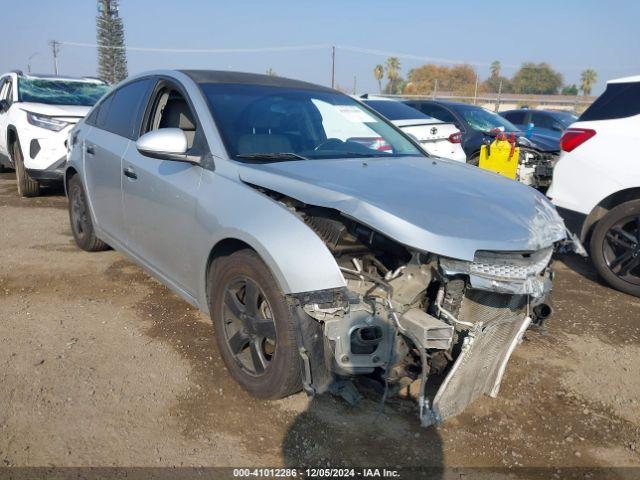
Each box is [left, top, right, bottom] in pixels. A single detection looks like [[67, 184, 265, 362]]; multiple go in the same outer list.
[[239, 157, 566, 261]]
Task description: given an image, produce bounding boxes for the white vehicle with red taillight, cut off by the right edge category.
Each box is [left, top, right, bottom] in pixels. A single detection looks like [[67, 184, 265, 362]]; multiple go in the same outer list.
[[547, 75, 640, 296]]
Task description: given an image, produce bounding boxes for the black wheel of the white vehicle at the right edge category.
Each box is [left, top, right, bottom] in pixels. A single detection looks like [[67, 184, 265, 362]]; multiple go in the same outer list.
[[589, 200, 640, 297]]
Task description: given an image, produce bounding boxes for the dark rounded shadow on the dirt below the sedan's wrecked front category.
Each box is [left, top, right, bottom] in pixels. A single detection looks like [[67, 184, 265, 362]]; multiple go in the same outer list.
[[282, 388, 444, 479]]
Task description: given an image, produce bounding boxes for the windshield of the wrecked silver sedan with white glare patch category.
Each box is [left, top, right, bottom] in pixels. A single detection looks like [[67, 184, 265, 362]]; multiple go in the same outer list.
[[200, 83, 424, 161]]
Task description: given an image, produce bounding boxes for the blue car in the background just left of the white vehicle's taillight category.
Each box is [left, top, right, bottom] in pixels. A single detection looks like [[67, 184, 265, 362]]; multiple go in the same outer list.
[[500, 108, 578, 145]]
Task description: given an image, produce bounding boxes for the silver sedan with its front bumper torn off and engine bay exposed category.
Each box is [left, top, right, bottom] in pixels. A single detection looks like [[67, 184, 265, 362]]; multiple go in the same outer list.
[[65, 70, 566, 424]]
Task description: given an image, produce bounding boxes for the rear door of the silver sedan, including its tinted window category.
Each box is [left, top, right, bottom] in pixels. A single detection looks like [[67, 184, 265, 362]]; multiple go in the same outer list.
[[83, 79, 151, 245]]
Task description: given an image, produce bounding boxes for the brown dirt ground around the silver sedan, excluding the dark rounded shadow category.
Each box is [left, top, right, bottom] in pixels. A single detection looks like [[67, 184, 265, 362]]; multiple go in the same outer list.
[[0, 174, 640, 478]]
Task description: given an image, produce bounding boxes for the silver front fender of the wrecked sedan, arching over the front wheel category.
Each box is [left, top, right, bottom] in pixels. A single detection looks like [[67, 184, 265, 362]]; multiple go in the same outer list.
[[197, 171, 346, 305]]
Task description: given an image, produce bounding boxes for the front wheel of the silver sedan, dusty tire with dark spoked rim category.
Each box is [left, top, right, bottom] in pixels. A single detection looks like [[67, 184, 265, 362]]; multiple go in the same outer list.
[[209, 249, 302, 399]]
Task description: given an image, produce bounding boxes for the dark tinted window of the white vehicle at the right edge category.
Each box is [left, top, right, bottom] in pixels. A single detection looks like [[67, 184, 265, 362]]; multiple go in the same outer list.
[[578, 82, 640, 122]]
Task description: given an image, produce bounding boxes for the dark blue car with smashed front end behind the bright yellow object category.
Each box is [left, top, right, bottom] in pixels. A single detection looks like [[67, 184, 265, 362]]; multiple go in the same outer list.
[[405, 100, 559, 190]]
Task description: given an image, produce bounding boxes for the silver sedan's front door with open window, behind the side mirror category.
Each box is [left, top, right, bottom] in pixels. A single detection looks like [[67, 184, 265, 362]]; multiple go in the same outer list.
[[122, 79, 208, 295]]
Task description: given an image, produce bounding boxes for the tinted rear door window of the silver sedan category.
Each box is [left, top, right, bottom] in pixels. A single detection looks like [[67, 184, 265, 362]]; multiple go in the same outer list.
[[97, 78, 152, 139]]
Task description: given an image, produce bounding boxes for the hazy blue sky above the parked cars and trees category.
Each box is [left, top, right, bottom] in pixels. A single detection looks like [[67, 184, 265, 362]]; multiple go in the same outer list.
[[0, 0, 640, 94]]
